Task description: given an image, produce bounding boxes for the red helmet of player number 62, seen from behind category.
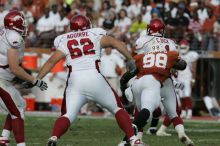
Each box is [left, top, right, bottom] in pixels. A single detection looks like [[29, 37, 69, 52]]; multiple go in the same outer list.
[[70, 15, 91, 31]]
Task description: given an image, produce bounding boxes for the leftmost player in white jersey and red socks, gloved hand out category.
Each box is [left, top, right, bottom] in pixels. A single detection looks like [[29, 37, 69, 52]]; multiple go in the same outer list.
[[0, 11, 47, 146]]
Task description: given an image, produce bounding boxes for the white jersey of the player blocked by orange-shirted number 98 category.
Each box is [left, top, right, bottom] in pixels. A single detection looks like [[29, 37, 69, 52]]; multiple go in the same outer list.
[[136, 30, 177, 54]]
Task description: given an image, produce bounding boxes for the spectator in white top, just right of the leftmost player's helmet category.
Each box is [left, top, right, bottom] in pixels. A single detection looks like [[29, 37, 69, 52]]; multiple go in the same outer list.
[[35, 8, 55, 48]]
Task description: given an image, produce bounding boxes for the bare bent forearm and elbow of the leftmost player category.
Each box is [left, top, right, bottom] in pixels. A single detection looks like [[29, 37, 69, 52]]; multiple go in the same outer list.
[[7, 48, 35, 83]]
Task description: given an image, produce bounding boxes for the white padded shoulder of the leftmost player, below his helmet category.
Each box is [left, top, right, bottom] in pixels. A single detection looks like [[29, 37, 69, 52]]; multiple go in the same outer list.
[[5, 30, 24, 48]]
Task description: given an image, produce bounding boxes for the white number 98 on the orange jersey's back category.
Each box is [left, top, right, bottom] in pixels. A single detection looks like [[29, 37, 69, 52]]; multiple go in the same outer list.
[[143, 53, 167, 68]]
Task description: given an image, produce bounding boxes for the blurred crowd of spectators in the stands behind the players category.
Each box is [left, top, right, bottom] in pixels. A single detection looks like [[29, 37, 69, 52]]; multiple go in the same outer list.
[[0, 0, 220, 50]]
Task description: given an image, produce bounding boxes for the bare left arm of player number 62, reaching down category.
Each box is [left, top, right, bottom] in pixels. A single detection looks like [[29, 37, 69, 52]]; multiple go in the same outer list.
[[37, 50, 65, 79]]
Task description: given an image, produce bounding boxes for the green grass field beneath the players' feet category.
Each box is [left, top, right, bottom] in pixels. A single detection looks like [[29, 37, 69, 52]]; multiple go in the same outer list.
[[0, 116, 220, 146]]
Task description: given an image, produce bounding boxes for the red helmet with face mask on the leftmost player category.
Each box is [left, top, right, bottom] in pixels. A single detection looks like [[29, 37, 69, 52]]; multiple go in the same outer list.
[[4, 10, 28, 36]]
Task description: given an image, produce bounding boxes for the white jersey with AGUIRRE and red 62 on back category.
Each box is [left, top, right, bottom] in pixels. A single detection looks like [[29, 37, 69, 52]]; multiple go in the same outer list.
[[54, 28, 106, 71]]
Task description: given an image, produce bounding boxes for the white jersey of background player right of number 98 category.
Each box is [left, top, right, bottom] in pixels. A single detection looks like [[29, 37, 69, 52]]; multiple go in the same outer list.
[[178, 51, 199, 81]]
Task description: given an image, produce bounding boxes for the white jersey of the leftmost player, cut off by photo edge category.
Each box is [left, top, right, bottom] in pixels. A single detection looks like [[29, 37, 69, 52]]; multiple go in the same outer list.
[[0, 27, 25, 81]]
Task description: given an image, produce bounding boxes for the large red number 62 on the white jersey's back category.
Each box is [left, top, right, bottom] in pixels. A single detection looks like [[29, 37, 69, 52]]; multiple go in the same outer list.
[[67, 38, 95, 59]]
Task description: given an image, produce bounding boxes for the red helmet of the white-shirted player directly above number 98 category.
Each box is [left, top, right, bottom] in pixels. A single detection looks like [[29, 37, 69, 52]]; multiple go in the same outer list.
[[147, 18, 165, 37]]
